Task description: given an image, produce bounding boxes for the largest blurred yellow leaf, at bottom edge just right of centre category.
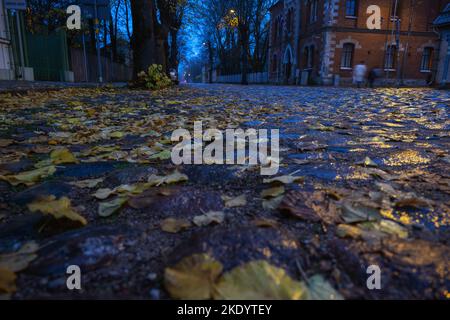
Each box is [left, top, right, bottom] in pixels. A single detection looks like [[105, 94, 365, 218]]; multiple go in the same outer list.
[[214, 260, 308, 300]]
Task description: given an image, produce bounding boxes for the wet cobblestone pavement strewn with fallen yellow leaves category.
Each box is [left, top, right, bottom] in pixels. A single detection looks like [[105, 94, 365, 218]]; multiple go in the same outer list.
[[0, 85, 450, 299]]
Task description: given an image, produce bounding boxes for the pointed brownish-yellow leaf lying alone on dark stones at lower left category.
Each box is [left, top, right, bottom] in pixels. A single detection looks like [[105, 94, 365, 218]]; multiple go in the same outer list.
[[28, 195, 87, 225]]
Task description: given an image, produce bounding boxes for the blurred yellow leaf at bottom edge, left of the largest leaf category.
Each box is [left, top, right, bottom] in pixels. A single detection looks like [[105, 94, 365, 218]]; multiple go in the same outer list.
[[164, 254, 223, 300]]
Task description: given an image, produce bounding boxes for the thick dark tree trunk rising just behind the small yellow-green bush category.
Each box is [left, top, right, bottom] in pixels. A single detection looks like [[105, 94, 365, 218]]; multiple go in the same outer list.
[[131, 0, 160, 77]]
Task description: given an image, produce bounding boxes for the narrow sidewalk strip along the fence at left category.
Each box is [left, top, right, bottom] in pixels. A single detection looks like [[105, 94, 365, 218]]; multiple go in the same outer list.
[[0, 80, 127, 93]]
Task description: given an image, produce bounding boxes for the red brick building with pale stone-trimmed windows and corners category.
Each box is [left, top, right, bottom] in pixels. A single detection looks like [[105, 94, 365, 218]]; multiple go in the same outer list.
[[268, 0, 448, 84]]
